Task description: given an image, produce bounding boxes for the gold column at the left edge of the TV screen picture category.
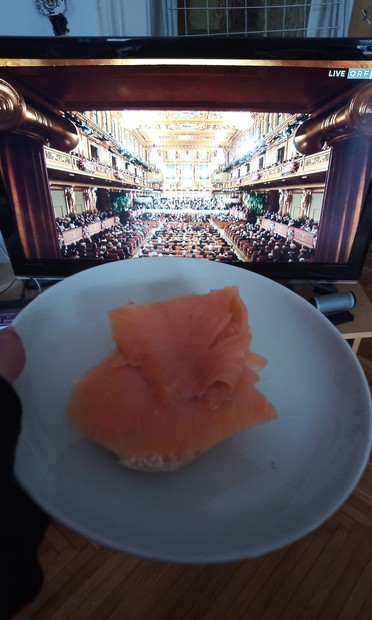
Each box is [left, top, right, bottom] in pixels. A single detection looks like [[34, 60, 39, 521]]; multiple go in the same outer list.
[[0, 79, 79, 259]]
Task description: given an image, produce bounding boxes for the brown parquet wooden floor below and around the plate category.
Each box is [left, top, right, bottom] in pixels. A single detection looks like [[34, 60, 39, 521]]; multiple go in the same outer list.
[[10, 250, 372, 620]]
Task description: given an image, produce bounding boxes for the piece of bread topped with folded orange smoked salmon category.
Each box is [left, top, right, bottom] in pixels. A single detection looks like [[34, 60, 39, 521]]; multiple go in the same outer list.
[[68, 286, 276, 471]]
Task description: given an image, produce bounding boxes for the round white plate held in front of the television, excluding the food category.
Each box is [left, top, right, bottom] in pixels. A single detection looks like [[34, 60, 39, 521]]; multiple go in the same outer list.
[[14, 257, 372, 562]]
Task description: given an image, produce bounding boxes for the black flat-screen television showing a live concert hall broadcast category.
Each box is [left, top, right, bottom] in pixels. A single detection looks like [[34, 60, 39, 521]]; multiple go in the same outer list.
[[0, 37, 372, 282]]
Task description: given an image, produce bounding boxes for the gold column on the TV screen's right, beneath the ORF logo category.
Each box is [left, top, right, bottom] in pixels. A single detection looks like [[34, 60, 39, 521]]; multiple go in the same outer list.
[[294, 82, 372, 263]]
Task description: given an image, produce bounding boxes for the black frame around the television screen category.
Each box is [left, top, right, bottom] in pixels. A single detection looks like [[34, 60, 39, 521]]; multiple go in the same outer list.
[[0, 37, 372, 283]]
